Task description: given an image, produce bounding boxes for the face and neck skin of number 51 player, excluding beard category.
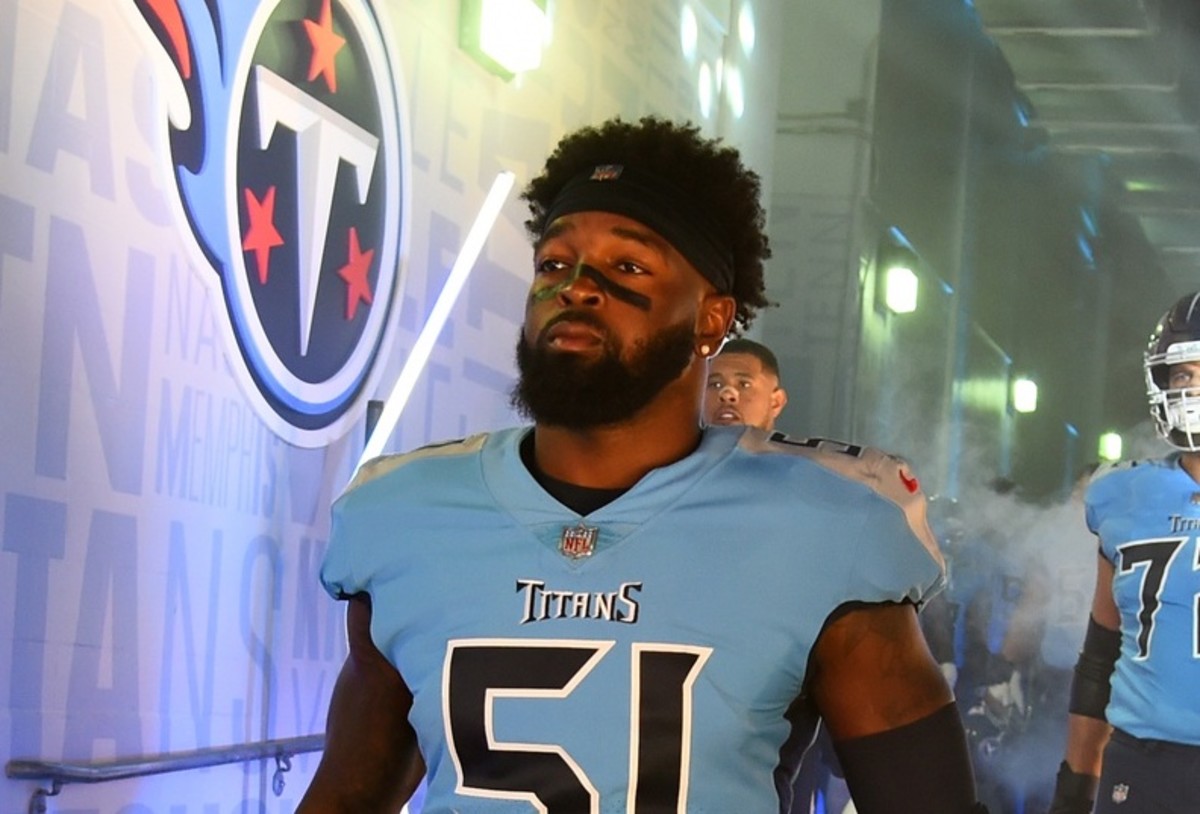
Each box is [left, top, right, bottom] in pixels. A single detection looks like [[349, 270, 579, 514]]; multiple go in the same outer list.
[[524, 213, 734, 489]]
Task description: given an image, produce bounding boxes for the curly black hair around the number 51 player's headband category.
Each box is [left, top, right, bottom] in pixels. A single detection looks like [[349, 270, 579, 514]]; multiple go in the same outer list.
[[521, 115, 772, 334]]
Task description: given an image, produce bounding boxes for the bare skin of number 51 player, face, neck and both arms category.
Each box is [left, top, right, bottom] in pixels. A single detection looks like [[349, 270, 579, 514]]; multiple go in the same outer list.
[[296, 213, 953, 814]]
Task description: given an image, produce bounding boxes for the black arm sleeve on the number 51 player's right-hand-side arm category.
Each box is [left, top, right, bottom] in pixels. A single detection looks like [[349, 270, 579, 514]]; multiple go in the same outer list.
[[834, 702, 985, 814]]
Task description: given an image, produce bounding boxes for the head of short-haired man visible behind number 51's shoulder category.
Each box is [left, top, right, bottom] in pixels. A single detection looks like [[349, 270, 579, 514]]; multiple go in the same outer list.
[[704, 337, 787, 431]]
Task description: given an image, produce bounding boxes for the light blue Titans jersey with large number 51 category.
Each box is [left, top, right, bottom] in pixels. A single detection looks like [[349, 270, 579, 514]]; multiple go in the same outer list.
[[322, 427, 942, 814]]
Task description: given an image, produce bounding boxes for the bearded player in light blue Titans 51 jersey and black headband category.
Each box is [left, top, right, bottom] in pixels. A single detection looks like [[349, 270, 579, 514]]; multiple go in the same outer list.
[[299, 118, 978, 814]]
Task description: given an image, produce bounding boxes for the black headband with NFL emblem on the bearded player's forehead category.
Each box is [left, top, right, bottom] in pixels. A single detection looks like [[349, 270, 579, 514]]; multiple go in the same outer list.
[[546, 164, 733, 294]]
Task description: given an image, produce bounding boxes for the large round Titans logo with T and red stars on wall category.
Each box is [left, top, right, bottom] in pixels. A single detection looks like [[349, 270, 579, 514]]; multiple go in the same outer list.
[[130, 0, 409, 447]]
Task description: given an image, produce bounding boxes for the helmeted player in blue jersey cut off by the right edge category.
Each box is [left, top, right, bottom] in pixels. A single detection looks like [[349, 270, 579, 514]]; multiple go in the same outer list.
[[1050, 293, 1200, 814]]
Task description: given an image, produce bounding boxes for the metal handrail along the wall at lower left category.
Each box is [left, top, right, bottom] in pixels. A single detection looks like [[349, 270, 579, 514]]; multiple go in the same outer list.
[[5, 732, 325, 814]]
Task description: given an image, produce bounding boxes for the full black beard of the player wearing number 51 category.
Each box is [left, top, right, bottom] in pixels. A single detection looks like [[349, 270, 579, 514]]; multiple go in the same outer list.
[[511, 313, 700, 430]]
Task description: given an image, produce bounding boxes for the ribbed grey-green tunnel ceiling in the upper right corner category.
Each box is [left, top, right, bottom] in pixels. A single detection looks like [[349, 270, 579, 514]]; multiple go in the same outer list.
[[974, 0, 1200, 295]]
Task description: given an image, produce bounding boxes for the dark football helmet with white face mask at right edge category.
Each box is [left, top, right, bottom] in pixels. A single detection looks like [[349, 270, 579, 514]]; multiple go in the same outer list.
[[1145, 292, 1200, 451]]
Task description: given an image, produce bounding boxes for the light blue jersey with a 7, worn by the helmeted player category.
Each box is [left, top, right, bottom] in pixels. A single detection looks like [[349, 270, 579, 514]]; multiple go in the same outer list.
[[1086, 455, 1200, 744]]
